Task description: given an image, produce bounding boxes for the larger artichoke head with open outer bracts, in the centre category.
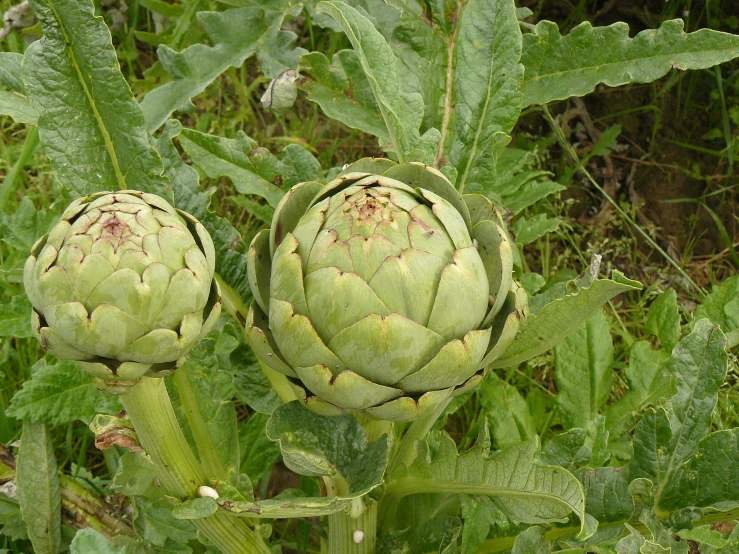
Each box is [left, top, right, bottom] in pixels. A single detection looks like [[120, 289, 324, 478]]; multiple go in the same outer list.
[[247, 159, 527, 421]]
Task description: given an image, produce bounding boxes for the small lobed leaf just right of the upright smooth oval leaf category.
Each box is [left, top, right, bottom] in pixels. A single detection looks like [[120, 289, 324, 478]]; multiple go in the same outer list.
[[605, 340, 671, 436]]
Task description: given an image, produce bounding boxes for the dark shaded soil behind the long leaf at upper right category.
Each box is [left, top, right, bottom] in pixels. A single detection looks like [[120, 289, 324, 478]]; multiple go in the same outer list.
[[518, 0, 739, 286]]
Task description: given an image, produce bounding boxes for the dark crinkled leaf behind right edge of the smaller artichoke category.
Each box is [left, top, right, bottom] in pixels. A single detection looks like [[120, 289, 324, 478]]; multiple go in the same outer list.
[[156, 121, 251, 306]]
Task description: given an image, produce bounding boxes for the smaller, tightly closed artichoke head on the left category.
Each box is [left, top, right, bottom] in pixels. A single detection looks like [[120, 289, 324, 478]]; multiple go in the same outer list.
[[23, 190, 221, 392]]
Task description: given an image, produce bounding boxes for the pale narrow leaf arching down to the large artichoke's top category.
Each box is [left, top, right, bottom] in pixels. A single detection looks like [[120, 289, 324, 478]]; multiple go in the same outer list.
[[316, 2, 440, 163]]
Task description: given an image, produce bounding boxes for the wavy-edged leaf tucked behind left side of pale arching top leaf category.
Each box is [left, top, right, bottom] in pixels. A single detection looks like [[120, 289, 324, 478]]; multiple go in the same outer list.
[[299, 50, 390, 145]]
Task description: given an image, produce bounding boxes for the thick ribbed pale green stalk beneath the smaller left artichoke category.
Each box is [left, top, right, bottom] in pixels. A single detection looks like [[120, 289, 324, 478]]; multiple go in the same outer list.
[[121, 377, 271, 554]]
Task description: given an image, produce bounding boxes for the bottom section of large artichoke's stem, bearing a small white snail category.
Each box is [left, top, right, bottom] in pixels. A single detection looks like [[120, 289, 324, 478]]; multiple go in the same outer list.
[[328, 500, 377, 554]]
